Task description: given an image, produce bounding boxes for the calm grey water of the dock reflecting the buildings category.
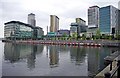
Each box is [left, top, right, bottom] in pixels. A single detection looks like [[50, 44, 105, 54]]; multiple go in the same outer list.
[[0, 42, 117, 76]]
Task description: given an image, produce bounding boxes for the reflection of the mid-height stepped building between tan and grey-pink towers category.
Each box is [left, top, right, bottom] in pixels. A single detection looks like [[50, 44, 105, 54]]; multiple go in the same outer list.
[[70, 47, 86, 65]]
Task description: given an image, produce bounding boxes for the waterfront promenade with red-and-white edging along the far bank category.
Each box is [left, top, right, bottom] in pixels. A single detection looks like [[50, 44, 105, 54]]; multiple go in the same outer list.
[[3, 40, 120, 47]]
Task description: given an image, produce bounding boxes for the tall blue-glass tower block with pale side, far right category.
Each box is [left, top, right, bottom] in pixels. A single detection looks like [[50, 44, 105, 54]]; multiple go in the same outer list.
[[99, 5, 118, 35]]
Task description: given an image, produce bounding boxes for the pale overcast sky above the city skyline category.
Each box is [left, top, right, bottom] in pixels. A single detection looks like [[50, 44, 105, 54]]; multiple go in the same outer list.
[[0, 0, 119, 38]]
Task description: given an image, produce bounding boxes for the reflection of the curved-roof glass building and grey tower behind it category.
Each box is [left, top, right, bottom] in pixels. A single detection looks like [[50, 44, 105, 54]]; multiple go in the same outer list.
[[4, 43, 44, 69]]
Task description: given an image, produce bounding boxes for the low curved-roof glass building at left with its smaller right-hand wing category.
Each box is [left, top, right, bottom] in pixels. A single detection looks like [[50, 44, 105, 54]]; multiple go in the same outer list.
[[4, 21, 44, 40]]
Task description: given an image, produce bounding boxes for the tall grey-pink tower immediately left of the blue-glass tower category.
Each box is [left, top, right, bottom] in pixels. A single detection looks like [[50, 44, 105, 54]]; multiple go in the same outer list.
[[88, 6, 99, 27]]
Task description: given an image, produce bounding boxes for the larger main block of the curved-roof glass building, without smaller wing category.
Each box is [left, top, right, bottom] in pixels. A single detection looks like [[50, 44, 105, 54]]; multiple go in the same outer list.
[[4, 21, 33, 39]]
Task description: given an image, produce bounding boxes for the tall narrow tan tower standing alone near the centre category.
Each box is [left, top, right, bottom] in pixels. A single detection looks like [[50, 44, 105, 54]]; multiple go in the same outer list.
[[50, 15, 59, 32]]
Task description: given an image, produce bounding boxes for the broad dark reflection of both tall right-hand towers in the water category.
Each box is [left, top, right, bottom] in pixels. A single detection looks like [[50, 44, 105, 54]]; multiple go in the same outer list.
[[87, 47, 117, 76]]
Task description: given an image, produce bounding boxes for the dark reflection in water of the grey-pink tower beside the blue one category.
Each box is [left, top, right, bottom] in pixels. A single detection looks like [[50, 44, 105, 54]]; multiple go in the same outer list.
[[87, 48, 100, 76]]
